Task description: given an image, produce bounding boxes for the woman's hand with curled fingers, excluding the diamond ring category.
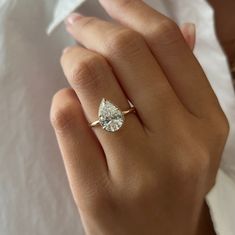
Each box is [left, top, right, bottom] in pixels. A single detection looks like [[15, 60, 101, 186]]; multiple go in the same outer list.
[[51, 0, 229, 235]]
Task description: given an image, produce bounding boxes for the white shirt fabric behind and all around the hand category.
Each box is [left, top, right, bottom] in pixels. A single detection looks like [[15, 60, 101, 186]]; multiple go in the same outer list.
[[0, 0, 235, 235]]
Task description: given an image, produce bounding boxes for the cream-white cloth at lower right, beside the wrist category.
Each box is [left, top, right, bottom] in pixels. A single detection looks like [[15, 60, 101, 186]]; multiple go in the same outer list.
[[206, 169, 235, 235]]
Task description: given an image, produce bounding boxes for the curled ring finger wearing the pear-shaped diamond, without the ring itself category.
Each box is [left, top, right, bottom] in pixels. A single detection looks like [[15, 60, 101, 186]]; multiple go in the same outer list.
[[61, 46, 144, 169]]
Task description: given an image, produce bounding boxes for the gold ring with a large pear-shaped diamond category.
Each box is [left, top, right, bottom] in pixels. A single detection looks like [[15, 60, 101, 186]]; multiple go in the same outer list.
[[90, 98, 135, 132]]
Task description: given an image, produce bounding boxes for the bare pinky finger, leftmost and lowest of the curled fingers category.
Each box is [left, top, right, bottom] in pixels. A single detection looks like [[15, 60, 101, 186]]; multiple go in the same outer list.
[[51, 89, 108, 209]]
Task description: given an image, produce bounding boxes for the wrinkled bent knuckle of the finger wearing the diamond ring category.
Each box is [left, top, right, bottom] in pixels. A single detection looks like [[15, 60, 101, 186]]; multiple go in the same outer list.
[[70, 55, 105, 90]]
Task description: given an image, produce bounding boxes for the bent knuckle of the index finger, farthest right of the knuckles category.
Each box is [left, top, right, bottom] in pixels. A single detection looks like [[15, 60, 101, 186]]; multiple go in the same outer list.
[[148, 19, 182, 46]]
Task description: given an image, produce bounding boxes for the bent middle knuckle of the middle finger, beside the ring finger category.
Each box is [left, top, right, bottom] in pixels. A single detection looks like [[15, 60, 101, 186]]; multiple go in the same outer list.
[[105, 28, 144, 56]]
